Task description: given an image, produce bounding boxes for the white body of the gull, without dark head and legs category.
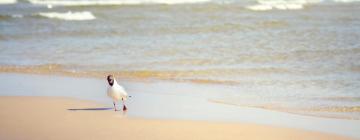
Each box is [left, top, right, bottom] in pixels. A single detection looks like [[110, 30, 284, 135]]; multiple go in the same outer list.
[[107, 79, 128, 102]]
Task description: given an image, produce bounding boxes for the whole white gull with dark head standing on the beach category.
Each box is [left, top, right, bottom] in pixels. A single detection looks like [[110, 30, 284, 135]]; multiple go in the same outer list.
[[107, 75, 128, 111]]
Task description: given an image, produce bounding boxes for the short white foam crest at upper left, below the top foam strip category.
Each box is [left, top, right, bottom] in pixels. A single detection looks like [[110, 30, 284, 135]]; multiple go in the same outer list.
[[39, 11, 96, 20]]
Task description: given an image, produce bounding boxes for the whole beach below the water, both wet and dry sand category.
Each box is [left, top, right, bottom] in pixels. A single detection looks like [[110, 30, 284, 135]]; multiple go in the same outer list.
[[0, 73, 360, 139]]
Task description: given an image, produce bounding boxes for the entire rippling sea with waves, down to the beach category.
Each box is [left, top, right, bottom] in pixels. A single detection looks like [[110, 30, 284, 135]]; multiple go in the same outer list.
[[0, 0, 360, 120]]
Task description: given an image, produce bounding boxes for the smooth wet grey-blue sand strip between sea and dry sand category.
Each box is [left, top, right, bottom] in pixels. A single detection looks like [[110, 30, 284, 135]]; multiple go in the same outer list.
[[0, 73, 360, 138]]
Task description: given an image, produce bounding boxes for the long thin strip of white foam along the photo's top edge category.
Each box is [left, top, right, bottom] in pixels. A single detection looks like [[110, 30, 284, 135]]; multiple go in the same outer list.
[[29, 0, 210, 6]]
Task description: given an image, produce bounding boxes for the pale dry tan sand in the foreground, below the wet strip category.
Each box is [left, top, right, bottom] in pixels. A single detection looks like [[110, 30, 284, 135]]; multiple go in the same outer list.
[[0, 96, 349, 140]]
